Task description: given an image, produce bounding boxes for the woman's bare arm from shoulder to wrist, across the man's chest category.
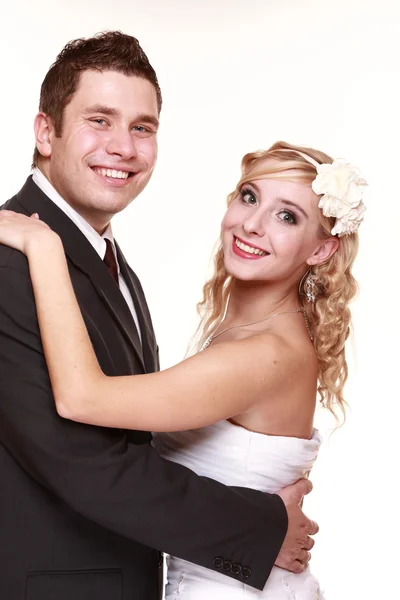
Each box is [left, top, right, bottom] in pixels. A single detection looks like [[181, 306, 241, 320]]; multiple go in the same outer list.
[[0, 210, 300, 431]]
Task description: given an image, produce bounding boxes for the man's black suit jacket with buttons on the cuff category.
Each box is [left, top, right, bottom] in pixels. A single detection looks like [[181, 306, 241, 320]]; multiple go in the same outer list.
[[0, 178, 287, 600]]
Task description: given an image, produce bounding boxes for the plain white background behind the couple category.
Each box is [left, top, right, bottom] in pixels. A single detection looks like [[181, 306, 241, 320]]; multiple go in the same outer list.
[[0, 0, 400, 600]]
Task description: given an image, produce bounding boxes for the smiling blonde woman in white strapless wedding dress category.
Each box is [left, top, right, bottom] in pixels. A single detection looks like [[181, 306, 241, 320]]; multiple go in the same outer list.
[[0, 142, 366, 600]]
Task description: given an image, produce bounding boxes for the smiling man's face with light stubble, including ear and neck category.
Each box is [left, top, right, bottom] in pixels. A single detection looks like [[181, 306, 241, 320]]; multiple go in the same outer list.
[[35, 70, 158, 232]]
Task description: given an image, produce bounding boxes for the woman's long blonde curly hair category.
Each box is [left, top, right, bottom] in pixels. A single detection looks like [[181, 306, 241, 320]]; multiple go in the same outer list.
[[195, 142, 358, 421]]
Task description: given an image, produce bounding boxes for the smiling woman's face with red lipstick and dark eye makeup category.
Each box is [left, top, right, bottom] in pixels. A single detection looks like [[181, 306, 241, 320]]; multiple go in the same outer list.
[[221, 165, 337, 282]]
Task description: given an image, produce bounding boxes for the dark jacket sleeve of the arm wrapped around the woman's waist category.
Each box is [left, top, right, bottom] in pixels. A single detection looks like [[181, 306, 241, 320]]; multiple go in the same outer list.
[[0, 255, 287, 589]]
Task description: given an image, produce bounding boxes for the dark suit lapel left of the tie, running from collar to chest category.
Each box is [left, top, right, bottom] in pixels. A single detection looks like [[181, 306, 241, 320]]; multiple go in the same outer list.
[[14, 177, 145, 369]]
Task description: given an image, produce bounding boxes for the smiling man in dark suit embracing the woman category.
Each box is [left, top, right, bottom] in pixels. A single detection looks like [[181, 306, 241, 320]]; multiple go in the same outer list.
[[0, 32, 317, 600]]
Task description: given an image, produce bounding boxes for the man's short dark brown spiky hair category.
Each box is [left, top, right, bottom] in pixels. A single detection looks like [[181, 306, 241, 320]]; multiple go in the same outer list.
[[32, 31, 162, 167]]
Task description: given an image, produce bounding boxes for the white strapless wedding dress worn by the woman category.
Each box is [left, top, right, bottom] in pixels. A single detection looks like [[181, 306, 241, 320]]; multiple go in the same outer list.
[[153, 421, 323, 600]]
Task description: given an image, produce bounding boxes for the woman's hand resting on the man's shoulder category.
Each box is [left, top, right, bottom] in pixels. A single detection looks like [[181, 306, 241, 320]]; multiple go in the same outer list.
[[0, 210, 58, 254]]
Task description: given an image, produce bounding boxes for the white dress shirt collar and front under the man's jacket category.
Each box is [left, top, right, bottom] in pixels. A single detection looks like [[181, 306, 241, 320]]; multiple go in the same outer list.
[[33, 167, 141, 338]]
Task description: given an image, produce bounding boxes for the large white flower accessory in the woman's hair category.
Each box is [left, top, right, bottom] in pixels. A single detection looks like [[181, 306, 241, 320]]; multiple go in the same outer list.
[[311, 158, 368, 237]]
